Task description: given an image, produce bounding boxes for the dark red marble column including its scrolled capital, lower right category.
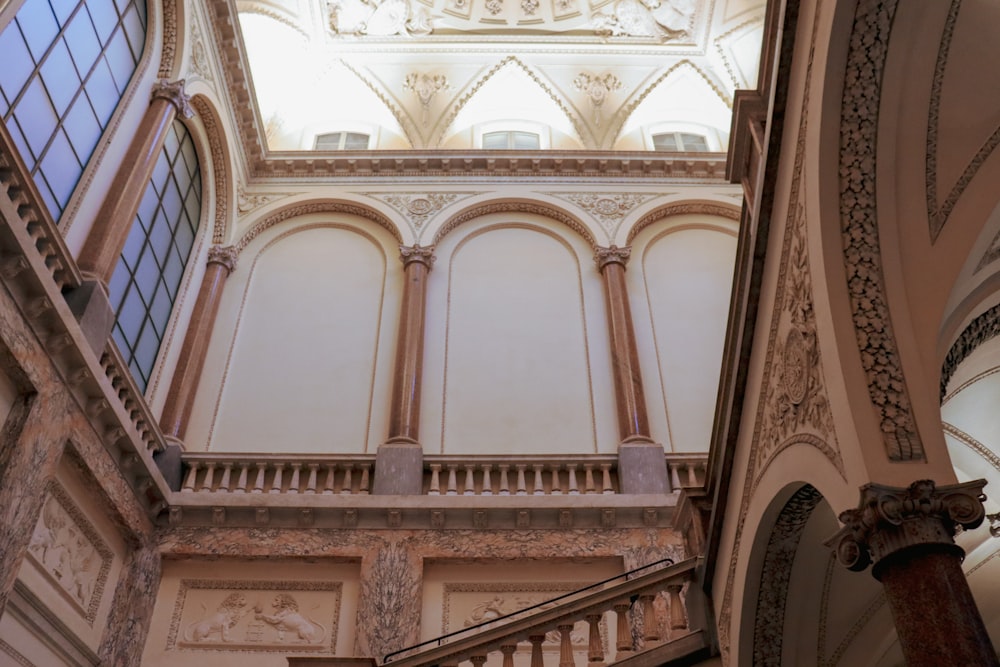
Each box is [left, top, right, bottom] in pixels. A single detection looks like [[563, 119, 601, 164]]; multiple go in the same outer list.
[[827, 480, 1000, 667]]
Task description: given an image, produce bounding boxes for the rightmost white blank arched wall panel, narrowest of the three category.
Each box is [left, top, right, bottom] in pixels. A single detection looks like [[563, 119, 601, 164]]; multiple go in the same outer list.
[[626, 219, 736, 452]]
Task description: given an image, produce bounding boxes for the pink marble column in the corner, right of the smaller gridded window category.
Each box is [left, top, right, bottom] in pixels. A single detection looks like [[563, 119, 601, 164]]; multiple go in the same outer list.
[[160, 246, 237, 440]]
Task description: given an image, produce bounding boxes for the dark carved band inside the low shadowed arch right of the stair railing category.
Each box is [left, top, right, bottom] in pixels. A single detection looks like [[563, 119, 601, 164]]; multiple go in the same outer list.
[[753, 484, 823, 667]]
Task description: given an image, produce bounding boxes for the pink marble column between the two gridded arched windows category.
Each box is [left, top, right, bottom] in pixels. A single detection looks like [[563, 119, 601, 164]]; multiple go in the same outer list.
[[77, 80, 194, 289]]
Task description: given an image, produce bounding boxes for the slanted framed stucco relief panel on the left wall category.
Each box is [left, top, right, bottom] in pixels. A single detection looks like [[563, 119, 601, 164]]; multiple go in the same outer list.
[[28, 483, 113, 624]]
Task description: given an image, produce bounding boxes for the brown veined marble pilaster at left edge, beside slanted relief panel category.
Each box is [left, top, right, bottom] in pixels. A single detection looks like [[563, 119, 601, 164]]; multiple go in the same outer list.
[[0, 394, 72, 616]]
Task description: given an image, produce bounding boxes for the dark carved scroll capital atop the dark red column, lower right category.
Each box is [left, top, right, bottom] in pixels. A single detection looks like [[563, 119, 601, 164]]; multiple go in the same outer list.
[[826, 479, 986, 574]]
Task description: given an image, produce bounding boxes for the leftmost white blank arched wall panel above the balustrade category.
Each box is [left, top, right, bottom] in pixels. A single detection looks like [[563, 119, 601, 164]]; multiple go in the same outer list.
[[187, 216, 402, 453]]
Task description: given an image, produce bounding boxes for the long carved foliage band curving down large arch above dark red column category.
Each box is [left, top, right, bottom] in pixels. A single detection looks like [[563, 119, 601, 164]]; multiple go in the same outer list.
[[840, 0, 925, 461]]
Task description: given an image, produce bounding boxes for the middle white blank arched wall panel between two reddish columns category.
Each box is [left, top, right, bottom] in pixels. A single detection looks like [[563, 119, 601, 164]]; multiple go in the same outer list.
[[422, 222, 615, 454]]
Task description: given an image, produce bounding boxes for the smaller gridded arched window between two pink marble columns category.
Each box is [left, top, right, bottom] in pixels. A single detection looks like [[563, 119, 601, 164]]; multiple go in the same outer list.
[[109, 120, 201, 390]]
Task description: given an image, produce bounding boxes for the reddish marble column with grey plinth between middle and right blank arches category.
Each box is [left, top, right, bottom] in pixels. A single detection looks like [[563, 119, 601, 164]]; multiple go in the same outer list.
[[594, 246, 670, 493]]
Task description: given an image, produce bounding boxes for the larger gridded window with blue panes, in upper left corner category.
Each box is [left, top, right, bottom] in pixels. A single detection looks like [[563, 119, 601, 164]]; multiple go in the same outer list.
[[0, 0, 146, 219]]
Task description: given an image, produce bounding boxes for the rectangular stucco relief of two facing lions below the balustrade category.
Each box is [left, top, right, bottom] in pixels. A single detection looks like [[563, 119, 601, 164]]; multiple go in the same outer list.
[[167, 579, 342, 653]]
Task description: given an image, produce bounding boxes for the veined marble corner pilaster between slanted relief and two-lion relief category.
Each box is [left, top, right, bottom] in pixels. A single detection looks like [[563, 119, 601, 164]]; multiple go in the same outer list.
[[98, 539, 163, 667]]
